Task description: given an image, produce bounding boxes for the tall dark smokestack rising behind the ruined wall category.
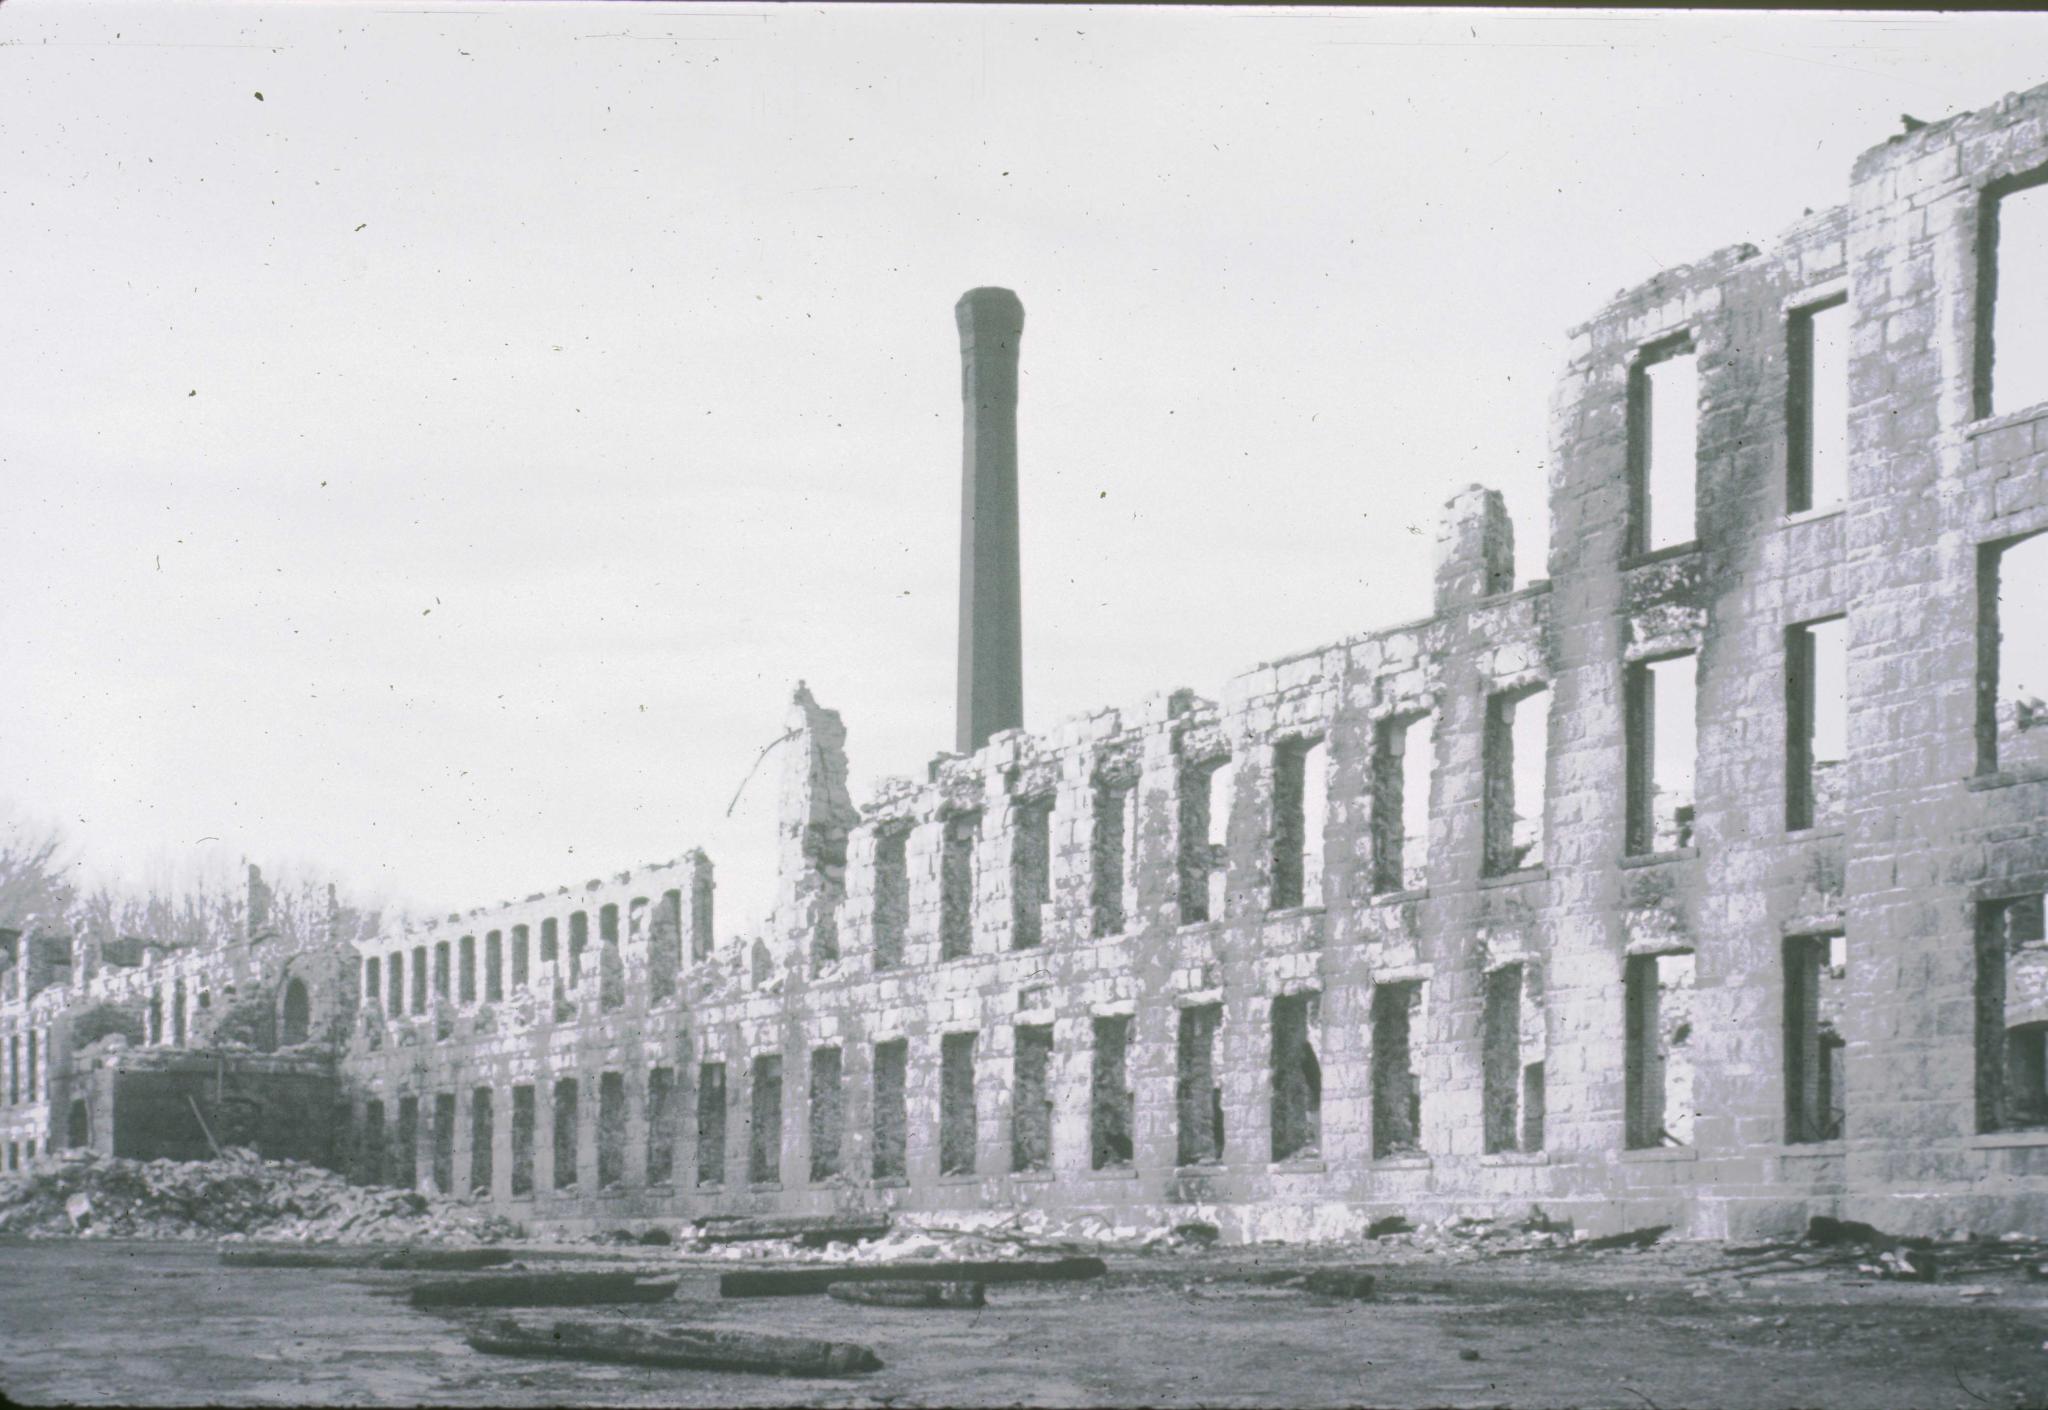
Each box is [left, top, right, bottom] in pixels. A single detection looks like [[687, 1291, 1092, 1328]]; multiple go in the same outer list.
[[952, 289, 1024, 754]]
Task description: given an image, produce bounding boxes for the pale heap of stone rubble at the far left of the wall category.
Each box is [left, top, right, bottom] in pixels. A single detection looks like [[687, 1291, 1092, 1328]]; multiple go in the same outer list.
[[0, 1148, 524, 1244]]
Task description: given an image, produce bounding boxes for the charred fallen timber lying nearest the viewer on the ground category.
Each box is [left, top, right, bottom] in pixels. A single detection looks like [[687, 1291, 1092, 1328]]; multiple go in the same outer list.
[[469, 1318, 883, 1375]]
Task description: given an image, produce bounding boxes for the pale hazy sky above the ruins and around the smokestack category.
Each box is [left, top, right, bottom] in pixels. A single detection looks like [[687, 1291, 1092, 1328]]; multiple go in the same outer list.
[[0, 0, 2048, 930]]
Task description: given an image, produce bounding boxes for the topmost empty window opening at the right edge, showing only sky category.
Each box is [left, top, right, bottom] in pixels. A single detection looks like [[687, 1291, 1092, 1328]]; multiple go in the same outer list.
[[1976, 168, 2048, 416]]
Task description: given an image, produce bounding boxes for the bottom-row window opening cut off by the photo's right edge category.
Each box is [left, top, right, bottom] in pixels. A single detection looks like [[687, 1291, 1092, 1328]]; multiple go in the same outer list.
[[1976, 894, 2048, 1131]]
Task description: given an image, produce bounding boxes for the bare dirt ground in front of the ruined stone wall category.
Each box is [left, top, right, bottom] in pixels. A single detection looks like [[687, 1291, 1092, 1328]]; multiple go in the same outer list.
[[0, 1242, 2048, 1410]]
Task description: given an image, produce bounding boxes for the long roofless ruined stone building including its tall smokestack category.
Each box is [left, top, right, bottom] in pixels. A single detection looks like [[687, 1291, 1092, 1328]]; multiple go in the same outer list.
[[0, 88, 2048, 1238]]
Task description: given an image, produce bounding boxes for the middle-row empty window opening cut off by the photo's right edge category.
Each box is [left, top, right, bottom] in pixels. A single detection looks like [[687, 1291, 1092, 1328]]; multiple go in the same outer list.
[[1976, 533, 2048, 773]]
